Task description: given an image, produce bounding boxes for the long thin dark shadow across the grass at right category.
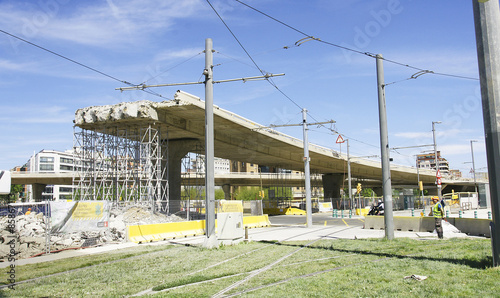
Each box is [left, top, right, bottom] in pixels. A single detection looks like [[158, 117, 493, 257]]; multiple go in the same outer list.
[[259, 240, 493, 269]]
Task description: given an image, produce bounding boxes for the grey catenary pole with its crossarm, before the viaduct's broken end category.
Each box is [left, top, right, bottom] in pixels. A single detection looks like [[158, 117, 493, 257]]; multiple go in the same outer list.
[[116, 38, 285, 248]]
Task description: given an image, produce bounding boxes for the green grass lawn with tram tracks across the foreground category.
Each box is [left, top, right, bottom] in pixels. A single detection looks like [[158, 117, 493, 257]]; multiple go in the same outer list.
[[0, 238, 500, 297]]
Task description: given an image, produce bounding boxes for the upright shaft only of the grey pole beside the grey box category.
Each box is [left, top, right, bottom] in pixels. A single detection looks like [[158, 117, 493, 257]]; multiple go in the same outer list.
[[203, 38, 217, 248]]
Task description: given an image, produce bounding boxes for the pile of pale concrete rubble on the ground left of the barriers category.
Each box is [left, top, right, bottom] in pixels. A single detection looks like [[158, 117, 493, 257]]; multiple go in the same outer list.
[[0, 206, 184, 262]]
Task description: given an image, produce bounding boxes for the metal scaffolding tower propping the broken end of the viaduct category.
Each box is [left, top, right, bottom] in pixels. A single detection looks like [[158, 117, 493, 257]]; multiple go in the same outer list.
[[73, 124, 168, 213]]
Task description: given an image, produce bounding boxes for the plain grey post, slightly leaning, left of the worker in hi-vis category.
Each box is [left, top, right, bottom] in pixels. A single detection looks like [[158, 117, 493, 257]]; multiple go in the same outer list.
[[377, 54, 394, 240]]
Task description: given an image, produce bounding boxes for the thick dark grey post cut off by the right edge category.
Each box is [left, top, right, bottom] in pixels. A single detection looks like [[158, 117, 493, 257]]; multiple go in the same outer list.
[[472, 0, 500, 266]]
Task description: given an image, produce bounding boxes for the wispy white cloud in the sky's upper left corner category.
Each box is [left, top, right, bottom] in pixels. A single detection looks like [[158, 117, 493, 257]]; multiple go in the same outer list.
[[0, 0, 206, 47]]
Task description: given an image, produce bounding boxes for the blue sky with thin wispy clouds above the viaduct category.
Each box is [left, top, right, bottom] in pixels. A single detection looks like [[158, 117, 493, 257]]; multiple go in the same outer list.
[[0, 0, 486, 177]]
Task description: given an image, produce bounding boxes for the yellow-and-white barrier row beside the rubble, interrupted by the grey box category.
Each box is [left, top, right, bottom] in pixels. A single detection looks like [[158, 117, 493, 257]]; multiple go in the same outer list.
[[127, 214, 271, 243]]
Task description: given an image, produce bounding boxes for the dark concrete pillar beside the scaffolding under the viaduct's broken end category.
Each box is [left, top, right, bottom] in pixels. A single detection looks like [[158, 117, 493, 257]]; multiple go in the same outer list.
[[166, 139, 200, 214]]
